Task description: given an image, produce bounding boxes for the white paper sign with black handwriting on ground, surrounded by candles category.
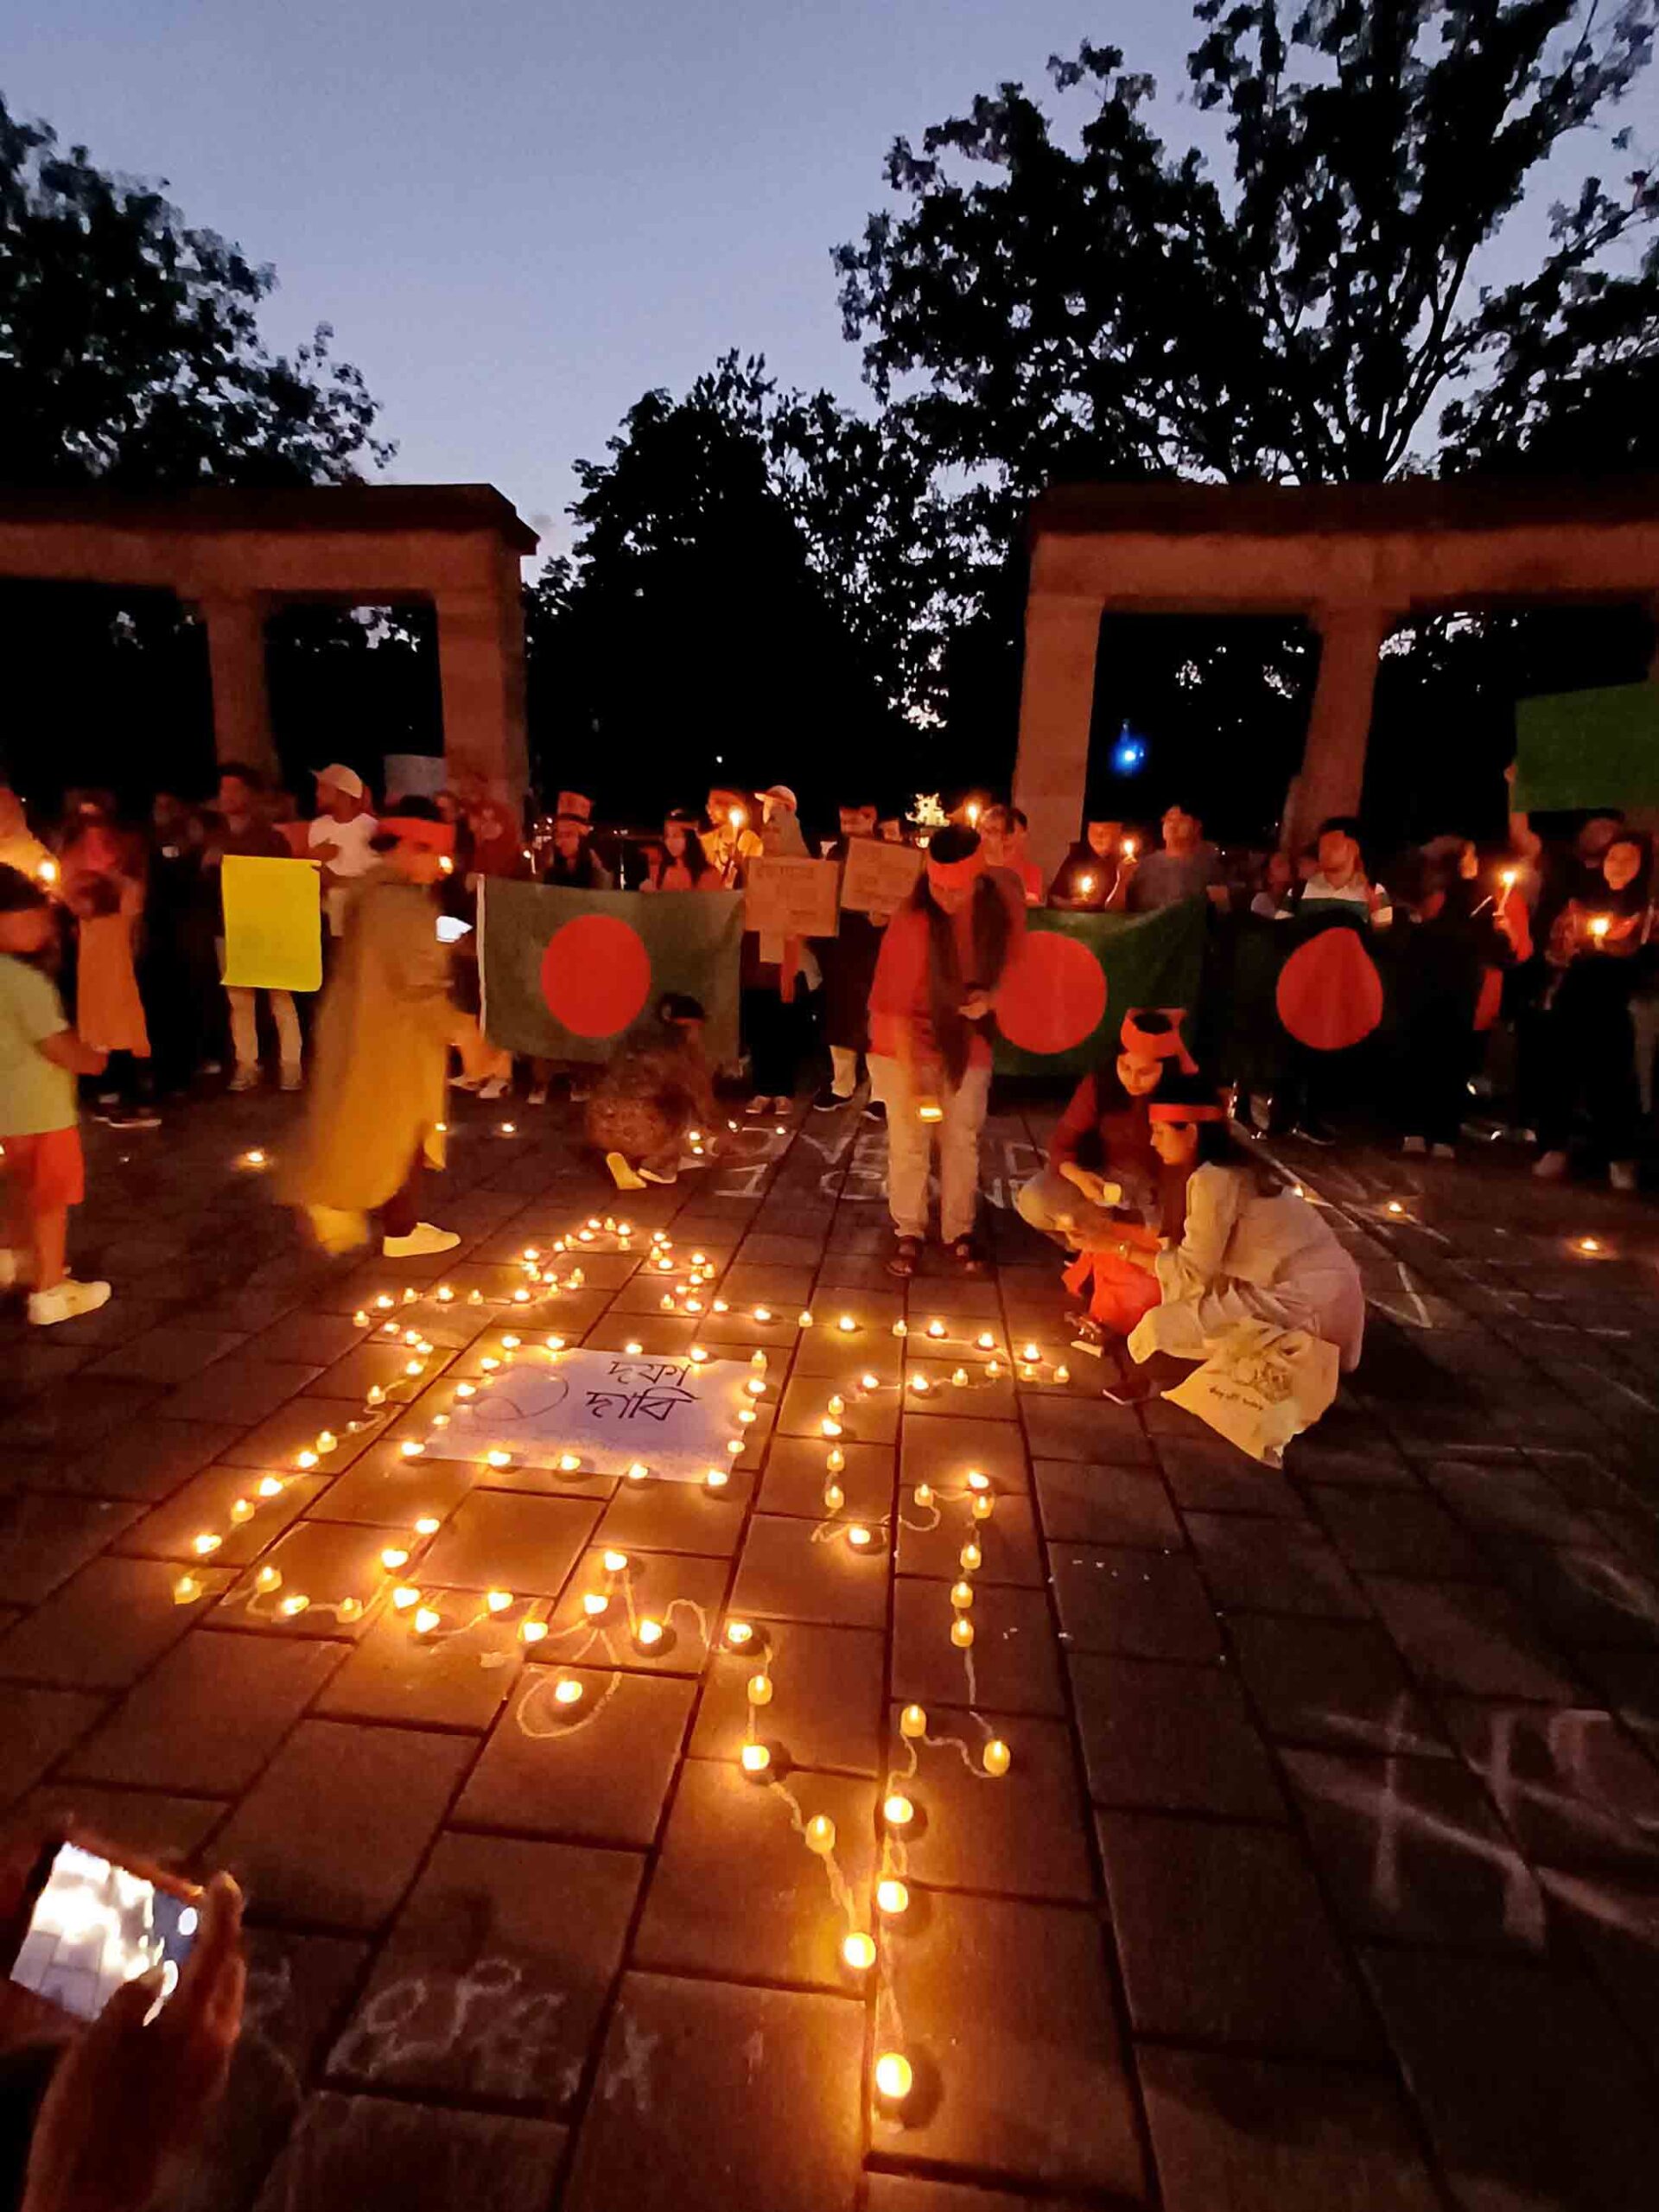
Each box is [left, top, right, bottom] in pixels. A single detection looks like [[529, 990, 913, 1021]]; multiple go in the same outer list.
[[445, 1347, 757, 1482]]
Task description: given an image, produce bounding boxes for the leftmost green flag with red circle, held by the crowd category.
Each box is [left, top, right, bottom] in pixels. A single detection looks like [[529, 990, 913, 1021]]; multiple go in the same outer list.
[[478, 876, 743, 1066]]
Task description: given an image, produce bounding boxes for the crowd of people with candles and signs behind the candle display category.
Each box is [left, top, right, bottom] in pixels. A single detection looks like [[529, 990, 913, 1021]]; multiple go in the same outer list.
[[0, 763, 1659, 1323]]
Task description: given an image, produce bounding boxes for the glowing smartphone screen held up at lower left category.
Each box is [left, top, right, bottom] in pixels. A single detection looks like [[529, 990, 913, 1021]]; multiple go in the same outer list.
[[11, 1842, 197, 2019]]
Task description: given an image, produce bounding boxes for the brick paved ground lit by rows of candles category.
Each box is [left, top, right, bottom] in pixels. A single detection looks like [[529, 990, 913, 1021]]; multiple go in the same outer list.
[[0, 1097, 1659, 2212]]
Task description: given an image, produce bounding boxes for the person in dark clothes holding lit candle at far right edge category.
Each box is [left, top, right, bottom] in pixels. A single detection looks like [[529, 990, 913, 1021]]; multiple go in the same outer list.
[[1533, 830, 1659, 1190]]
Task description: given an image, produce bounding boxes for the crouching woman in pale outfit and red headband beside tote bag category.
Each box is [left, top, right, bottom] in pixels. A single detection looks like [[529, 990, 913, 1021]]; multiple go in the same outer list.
[[1126, 1075, 1365, 1374]]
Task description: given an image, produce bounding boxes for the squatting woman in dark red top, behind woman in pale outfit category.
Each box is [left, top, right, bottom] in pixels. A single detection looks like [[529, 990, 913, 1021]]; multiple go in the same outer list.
[[1015, 1007, 1194, 1338]]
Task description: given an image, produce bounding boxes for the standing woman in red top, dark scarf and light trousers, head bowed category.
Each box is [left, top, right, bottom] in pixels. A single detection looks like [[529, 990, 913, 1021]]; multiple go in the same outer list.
[[869, 827, 1027, 1276]]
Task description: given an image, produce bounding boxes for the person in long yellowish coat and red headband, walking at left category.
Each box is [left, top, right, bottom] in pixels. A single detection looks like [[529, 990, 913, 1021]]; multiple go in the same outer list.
[[281, 798, 480, 1259]]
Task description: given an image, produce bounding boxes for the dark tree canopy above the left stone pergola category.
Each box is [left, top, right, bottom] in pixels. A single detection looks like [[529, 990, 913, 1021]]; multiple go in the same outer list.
[[0, 102, 391, 489]]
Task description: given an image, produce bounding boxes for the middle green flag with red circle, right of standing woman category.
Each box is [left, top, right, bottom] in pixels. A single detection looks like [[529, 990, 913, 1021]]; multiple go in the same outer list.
[[995, 898, 1208, 1075]]
